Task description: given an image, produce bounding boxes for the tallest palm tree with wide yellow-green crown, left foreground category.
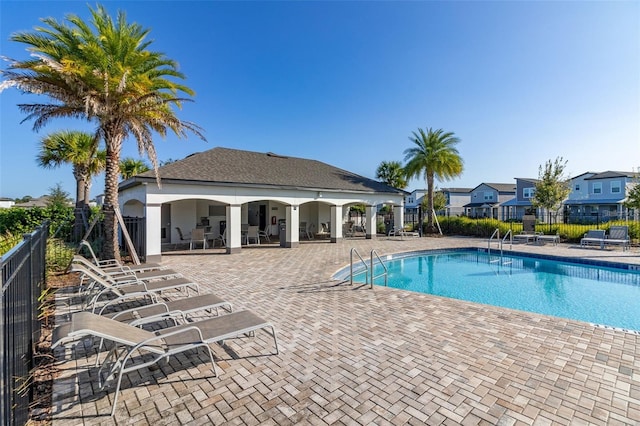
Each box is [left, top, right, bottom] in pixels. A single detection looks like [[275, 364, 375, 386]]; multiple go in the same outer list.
[[0, 5, 204, 259]]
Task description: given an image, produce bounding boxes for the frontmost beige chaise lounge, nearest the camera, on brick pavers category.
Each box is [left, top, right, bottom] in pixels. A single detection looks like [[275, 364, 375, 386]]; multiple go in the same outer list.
[[51, 311, 279, 416]]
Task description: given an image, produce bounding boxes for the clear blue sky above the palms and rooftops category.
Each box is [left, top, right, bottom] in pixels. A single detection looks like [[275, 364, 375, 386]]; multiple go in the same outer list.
[[0, 0, 640, 198]]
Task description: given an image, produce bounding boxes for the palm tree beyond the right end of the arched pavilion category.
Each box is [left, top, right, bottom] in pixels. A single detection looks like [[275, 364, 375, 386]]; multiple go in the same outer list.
[[404, 127, 463, 232]]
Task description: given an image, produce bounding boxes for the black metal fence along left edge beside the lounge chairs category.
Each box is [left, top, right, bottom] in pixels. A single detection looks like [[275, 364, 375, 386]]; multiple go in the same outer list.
[[0, 224, 49, 425]]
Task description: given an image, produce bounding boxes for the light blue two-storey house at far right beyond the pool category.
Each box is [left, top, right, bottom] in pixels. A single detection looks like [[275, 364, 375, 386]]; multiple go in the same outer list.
[[564, 171, 635, 223]]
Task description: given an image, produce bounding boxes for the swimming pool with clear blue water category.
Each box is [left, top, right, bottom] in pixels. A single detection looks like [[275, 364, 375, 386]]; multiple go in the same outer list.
[[343, 249, 640, 332]]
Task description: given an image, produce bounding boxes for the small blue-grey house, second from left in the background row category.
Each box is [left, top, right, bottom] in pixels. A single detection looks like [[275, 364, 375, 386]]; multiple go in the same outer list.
[[463, 183, 516, 220]]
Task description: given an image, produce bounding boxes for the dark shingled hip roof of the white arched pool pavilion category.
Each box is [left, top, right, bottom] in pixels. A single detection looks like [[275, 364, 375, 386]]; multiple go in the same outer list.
[[126, 147, 405, 194]]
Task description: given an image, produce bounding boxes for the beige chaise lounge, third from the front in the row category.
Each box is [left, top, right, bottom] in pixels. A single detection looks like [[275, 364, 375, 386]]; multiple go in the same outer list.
[[71, 263, 200, 309]]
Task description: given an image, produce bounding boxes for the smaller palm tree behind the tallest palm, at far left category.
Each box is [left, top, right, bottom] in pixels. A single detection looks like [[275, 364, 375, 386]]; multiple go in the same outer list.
[[36, 130, 106, 239]]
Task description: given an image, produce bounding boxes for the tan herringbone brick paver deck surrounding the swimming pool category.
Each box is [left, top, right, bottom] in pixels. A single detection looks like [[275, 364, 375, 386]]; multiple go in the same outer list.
[[53, 238, 640, 425]]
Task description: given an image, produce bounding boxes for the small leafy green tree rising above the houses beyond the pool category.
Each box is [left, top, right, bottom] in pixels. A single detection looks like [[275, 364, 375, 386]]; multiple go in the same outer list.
[[531, 157, 571, 211]]
